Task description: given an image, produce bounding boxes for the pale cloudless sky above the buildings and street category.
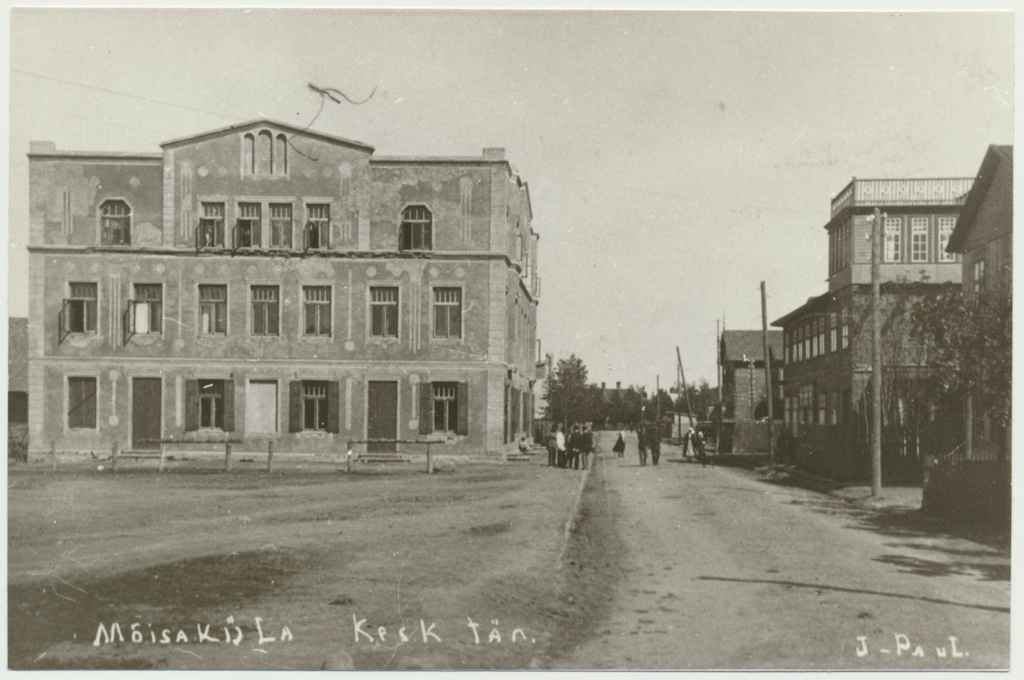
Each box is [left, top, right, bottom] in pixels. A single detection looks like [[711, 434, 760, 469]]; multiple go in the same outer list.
[[8, 3, 1014, 389]]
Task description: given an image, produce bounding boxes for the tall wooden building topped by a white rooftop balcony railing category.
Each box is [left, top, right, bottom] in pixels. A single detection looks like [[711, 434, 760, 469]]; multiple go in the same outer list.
[[772, 178, 974, 479]]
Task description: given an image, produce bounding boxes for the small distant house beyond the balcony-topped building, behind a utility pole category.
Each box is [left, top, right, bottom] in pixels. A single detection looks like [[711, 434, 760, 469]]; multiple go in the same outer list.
[[719, 331, 782, 422]]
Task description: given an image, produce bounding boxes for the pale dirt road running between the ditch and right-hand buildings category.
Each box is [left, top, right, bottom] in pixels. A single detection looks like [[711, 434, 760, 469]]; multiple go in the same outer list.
[[555, 437, 1010, 670]]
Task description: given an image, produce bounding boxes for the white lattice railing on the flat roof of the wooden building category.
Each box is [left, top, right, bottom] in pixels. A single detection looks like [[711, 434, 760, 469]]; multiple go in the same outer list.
[[831, 177, 974, 217]]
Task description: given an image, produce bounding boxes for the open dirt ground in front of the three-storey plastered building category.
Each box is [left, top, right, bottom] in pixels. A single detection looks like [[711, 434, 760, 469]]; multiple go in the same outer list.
[[7, 456, 592, 670]]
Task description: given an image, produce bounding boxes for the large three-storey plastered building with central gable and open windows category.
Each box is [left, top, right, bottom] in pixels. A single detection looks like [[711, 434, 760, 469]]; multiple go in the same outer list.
[[29, 120, 540, 456]]
